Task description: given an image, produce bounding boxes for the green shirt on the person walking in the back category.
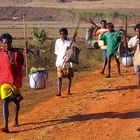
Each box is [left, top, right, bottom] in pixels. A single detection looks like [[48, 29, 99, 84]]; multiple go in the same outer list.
[[101, 31, 121, 56]]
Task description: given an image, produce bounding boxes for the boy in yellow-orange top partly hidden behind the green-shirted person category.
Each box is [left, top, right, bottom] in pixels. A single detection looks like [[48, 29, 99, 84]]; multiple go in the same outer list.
[[93, 20, 108, 74]]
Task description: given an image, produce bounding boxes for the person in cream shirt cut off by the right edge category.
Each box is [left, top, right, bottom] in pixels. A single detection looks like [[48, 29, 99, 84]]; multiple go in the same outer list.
[[128, 23, 140, 87]]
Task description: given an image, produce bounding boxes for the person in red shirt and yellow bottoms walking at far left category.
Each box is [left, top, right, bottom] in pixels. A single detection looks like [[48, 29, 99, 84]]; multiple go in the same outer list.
[[0, 33, 24, 133]]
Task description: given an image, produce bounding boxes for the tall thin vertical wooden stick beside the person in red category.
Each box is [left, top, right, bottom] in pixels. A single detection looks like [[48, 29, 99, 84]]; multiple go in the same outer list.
[[23, 14, 28, 79]]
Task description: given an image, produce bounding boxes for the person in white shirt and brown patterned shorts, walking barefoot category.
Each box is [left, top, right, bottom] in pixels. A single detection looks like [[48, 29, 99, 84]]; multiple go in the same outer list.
[[54, 28, 74, 96]]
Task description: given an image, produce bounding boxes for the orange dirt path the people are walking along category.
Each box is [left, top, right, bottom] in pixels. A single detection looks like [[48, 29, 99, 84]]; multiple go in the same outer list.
[[0, 64, 140, 140]]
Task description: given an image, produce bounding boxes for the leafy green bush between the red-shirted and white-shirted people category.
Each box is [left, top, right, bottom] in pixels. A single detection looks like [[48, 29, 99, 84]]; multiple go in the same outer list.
[[28, 28, 53, 68]]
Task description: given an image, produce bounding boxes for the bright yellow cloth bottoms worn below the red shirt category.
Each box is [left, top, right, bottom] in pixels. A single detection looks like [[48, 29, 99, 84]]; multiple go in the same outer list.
[[0, 83, 19, 100]]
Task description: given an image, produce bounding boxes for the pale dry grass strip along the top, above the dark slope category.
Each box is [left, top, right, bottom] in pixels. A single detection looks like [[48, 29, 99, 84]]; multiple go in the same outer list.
[[0, 0, 140, 9]]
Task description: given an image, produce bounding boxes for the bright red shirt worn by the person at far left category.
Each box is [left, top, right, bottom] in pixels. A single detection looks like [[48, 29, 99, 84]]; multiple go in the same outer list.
[[0, 49, 24, 88]]
